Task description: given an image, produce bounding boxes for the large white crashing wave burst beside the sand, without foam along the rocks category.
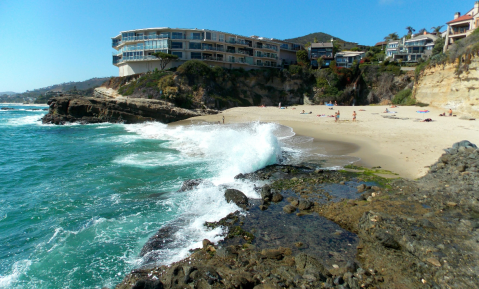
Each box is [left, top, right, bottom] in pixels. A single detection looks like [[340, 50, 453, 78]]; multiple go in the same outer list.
[[125, 123, 281, 180]]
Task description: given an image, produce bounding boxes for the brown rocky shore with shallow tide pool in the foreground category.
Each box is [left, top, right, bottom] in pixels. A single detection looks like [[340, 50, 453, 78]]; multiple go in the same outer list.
[[112, 142, 479, 289]]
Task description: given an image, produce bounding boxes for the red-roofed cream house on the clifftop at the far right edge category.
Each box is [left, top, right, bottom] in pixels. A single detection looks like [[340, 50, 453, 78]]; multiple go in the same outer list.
[[444, 1, 479, 53]]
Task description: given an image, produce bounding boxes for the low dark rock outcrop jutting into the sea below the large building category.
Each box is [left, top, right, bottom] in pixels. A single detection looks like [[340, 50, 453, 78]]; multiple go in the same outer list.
[[42, 95, 216, 124]]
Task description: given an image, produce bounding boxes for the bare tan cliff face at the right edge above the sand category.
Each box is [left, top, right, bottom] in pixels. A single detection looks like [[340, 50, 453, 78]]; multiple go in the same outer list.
[[415, 57, 479, 117]]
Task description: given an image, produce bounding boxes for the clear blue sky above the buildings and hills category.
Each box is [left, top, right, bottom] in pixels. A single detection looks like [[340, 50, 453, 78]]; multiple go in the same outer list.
[[0, 0, 474, 92]]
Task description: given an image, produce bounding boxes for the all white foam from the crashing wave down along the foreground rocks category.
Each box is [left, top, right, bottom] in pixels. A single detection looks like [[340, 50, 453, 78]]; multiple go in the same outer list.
[[122, 123, 284, 264]]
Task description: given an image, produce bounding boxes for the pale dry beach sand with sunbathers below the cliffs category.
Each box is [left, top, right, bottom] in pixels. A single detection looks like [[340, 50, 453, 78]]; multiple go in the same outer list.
[[181, 105, 479, 179]]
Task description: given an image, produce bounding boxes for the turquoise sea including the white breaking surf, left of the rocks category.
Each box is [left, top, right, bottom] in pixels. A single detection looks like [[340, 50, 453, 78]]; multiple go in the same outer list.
[[0, 104, 288, 288]]
